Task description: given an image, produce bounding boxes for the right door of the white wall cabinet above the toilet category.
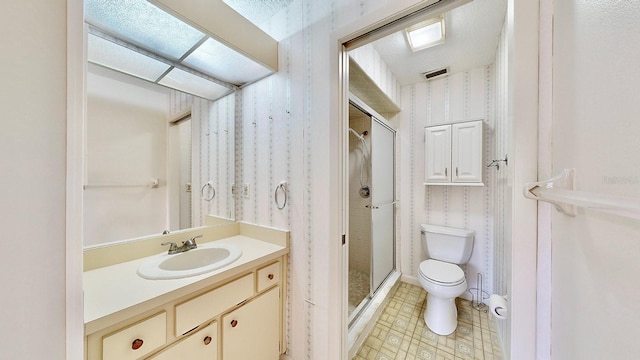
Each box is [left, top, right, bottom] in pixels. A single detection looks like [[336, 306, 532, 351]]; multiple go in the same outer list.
[[451, 121, 483, 183]]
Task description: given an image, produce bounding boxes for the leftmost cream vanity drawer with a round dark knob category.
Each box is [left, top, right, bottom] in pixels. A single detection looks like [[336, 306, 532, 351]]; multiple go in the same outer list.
[[102, 311, 167, 360]]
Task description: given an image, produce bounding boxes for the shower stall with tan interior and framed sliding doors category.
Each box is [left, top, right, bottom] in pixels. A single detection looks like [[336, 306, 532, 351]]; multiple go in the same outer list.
[[348, 102, 395, 324]]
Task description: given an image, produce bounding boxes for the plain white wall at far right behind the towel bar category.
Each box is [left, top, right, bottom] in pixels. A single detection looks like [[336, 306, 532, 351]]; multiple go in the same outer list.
[[551, 1, 640, 360]]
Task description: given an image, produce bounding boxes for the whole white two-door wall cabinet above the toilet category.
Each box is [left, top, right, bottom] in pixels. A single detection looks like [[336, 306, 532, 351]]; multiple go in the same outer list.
[[425, 120, 484, 186]]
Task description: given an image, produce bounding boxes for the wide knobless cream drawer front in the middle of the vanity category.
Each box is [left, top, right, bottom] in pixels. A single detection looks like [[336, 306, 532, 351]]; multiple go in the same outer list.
[[176, 273, 254, 336]]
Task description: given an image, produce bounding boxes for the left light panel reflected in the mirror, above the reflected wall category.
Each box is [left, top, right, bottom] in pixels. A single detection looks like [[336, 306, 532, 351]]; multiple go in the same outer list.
[[87, 34, 169, 82]]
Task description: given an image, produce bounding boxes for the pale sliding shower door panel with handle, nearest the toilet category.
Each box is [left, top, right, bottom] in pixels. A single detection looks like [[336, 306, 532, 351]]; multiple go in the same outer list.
[[371, 119, 395, 294]]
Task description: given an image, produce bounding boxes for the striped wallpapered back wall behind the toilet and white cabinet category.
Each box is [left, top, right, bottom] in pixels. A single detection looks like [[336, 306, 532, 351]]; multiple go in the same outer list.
[[399, 65, 498, 299]]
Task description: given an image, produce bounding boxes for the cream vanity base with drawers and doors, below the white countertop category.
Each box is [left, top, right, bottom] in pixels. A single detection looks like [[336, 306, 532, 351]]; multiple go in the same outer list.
[[85, 257, 286, 360]]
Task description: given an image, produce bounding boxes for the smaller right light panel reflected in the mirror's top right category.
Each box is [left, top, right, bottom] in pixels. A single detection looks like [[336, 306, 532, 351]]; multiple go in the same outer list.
[[158, 68, 232, 101]]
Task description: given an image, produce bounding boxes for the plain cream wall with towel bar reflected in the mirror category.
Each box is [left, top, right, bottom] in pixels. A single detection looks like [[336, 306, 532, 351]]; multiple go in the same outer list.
[[83, 66, 169, 245]]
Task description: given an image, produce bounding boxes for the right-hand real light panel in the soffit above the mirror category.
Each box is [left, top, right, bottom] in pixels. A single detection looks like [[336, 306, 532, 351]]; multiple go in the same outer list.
[[182, 38, 272, 86]]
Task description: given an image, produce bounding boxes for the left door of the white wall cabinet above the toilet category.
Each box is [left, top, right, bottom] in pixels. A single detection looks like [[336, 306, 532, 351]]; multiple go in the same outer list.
[[424, 125, 451, 183]]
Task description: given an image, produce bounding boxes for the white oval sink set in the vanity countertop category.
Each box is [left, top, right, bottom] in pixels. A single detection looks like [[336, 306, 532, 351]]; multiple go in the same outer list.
[[138, 244, 242, 280]]
